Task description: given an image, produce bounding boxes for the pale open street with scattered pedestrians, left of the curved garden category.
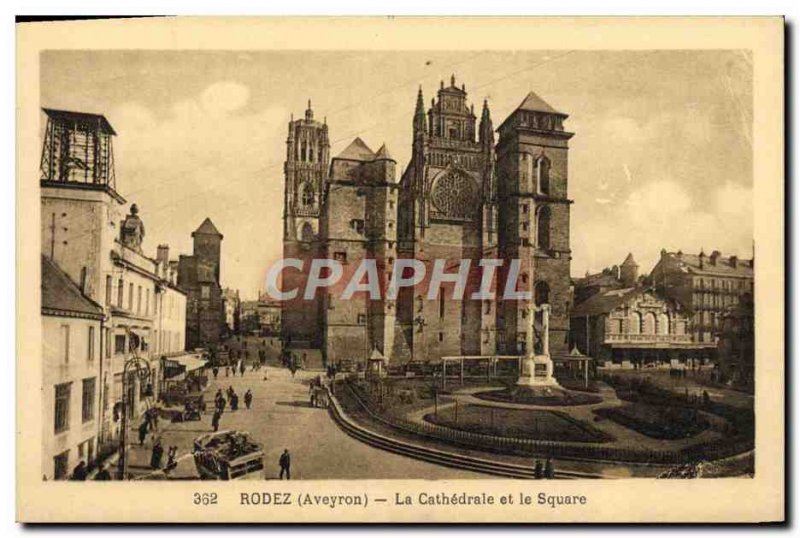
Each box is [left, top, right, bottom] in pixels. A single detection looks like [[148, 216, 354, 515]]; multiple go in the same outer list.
[[131, 356, 487, 479]]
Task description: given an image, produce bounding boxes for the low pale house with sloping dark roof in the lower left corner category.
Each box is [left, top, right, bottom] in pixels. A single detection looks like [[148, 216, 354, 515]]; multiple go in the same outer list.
[[42, 256, 105, 480]]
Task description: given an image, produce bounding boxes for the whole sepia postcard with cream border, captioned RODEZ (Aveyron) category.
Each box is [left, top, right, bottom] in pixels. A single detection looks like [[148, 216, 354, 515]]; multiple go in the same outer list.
[[15, 17, 785, 524]]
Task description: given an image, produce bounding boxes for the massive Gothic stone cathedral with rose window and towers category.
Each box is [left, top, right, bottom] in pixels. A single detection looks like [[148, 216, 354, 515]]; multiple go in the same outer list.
[[282, 77, 572, 364]]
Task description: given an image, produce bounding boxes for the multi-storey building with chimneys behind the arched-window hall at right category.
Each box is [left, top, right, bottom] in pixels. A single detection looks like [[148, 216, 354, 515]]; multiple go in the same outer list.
[[648, 250, 754, 348]]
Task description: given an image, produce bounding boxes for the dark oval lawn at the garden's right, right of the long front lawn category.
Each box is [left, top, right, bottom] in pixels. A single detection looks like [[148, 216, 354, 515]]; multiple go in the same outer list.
[[594, 402, 709, 439]]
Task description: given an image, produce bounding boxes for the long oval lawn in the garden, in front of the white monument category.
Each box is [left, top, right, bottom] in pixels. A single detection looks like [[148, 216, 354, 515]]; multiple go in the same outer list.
[[425, 405, 613, 443]]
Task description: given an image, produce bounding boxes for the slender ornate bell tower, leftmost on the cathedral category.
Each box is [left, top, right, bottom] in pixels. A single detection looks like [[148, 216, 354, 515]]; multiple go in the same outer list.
[[281, 100, 330, 347]]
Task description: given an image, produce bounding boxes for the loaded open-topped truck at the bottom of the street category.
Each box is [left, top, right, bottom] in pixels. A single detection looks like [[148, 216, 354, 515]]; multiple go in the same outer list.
[[192, 430, 264, 480]]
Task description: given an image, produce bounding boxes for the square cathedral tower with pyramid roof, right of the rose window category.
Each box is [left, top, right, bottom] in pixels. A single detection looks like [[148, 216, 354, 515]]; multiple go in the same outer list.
[[497, 92, 573, 356]]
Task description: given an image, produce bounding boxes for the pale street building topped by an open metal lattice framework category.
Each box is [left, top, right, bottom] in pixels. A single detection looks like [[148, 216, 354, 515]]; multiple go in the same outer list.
[[40, 109, 189, 450]]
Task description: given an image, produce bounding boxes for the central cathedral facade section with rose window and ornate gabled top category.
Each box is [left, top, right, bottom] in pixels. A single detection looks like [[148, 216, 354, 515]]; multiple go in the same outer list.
[[393, 76, 496, 360]]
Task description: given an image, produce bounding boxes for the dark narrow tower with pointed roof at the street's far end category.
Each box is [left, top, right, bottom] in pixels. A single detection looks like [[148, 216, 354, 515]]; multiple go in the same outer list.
[[178, 218, 225, 349]]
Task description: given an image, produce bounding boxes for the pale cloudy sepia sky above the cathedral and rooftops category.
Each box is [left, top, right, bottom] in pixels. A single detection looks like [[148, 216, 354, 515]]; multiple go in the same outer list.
[[37, 50, 753, 298]]
